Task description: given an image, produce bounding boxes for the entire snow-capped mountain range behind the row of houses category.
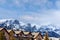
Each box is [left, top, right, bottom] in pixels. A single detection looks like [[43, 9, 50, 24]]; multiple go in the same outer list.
[[0, 19, 60, 37]]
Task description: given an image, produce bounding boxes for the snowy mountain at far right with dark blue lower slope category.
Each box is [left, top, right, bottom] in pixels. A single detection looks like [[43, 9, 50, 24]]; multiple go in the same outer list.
[[40, 24, 60, 37]]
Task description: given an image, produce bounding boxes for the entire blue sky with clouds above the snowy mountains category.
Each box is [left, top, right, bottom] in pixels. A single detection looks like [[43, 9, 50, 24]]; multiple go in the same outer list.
[[0, 0, 60, 26]]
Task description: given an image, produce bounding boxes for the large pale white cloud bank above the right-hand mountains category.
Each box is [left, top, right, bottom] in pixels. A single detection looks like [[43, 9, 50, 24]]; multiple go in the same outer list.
[[20, 10, 60, 25]]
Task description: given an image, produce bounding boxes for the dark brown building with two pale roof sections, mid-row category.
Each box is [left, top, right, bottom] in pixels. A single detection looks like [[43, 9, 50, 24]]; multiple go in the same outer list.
[[15, 31, 32, 40]]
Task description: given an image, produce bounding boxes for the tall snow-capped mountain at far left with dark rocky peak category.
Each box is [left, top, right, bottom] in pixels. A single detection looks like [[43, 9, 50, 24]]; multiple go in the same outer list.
[[0, 19, 20, 29]]
